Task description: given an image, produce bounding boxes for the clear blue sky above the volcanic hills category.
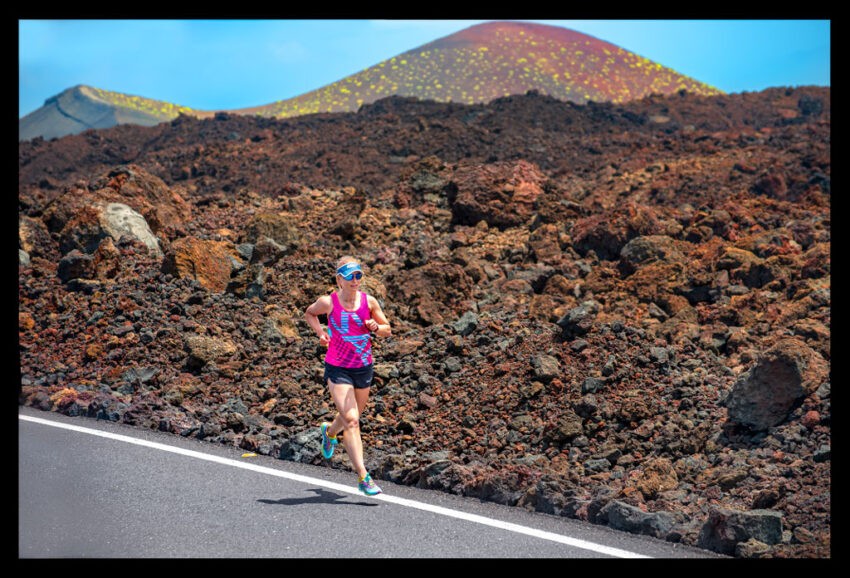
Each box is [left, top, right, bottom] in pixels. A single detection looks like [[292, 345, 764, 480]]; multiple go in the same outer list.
[[18, 20, 830, 117]]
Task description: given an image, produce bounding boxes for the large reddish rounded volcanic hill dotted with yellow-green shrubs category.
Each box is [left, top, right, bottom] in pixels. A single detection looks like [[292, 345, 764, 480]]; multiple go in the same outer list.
[[242, 21, 722, 118]]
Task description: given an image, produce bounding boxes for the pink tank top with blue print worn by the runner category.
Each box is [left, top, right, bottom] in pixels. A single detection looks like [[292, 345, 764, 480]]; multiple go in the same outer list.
[[325, 291, 372, 367]]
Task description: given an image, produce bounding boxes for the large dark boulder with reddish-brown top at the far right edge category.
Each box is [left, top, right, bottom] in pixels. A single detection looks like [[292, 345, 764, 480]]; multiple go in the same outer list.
[[725, 338, 829, 430]]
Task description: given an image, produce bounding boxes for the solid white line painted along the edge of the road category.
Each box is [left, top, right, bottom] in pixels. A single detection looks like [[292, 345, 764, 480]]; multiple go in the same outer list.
[[18, 414, 650, 558]]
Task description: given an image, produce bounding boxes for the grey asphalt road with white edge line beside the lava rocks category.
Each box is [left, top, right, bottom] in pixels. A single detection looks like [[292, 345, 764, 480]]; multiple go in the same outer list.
[[18, 407, 717, 558]]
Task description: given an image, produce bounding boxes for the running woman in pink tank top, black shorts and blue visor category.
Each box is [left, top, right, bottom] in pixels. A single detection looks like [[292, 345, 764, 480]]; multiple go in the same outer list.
[[304, 256, 392, 496]]
